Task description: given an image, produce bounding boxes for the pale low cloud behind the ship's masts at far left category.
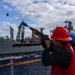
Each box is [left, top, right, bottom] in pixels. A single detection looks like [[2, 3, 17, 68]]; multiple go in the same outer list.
[[0, 22, 33, 38]]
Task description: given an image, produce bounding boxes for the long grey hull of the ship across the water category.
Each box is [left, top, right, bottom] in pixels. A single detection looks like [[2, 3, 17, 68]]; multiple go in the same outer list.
[[0, 39, 43, 55]]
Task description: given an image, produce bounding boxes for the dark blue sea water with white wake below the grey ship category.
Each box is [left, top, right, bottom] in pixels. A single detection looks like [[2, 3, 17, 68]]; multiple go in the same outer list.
[[0, 55, 51, 75]]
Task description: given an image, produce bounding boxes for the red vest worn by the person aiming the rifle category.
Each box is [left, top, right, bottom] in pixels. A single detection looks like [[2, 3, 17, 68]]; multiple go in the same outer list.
[[51, 43, 75, 75]]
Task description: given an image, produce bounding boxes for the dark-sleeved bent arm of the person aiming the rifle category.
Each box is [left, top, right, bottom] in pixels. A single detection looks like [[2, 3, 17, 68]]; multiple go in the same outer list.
[[42, 40, 71, 67]]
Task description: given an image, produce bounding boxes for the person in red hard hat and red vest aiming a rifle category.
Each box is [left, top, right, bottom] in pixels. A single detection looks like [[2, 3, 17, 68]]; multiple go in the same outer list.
[[42, 26, 75, 75]]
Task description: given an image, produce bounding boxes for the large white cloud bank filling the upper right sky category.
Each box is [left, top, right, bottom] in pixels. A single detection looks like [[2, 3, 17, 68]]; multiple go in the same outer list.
[[0, 0, 75, 37]]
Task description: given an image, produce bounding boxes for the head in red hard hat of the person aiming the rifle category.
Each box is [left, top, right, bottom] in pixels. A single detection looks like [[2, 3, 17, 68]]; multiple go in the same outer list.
[[51, 26, 72, 45]]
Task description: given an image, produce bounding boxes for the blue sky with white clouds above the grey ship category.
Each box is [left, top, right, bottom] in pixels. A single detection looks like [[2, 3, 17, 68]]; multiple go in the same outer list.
[[0, 0, 75, 38]]
